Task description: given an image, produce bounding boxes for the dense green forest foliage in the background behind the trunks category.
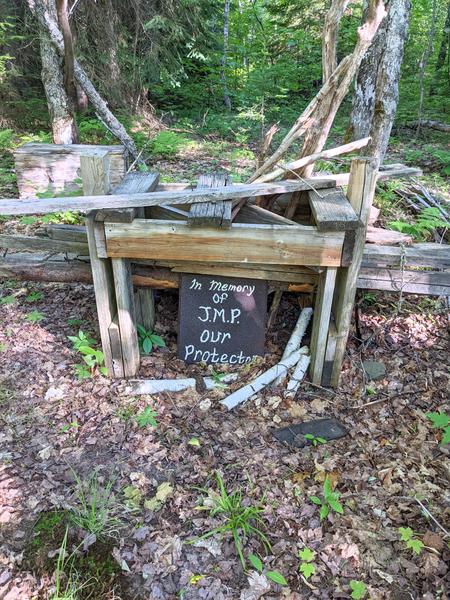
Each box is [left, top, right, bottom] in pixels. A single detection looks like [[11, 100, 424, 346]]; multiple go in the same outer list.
[[0, 0, 450, 137]]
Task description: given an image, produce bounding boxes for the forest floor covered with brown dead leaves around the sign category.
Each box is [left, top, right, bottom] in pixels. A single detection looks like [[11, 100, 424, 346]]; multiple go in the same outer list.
[[0, 282, 450, 600]]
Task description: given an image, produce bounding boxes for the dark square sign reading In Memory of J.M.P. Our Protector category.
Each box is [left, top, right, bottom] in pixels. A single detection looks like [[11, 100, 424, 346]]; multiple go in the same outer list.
[[178, 274, 267, 365]]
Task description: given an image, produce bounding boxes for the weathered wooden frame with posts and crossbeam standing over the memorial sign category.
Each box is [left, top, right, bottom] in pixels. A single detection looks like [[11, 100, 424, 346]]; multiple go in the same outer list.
[[75, 151, 377, 386]]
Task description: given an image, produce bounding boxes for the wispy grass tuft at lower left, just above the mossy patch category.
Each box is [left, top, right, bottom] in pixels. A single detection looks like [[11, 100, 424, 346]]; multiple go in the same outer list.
[[69, 470, 123, 541]]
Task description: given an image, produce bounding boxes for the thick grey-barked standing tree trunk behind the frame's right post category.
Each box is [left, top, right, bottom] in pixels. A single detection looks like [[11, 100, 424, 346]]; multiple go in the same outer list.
[[350, 0, 411, 163]]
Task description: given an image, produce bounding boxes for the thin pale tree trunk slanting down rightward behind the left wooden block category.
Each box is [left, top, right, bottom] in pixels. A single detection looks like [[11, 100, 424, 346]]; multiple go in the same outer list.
[[28, 0, 138, 158]]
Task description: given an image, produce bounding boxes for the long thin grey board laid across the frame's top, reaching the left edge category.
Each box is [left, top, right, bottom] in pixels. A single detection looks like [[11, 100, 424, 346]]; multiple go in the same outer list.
[[0, 177, 334, 215]]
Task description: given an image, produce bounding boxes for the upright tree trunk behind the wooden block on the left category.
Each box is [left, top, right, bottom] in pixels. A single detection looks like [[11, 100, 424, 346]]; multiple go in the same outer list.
[[28, 0, 76, 144]]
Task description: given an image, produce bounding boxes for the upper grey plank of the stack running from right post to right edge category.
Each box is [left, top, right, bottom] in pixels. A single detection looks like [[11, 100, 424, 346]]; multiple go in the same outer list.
[[362, 242, 450, 269]]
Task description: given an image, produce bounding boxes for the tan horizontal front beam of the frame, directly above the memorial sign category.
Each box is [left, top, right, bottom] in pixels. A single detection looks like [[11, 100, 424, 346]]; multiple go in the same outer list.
[[105, 219, 344, 267]]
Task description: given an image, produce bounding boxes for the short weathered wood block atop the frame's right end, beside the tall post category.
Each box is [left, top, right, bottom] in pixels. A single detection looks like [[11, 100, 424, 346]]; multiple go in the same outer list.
[[307, 189, 361, 231]]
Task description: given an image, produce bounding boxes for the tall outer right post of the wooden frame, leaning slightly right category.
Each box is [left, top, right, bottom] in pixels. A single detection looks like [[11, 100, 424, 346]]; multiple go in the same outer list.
[[327, 158, 378, 387]]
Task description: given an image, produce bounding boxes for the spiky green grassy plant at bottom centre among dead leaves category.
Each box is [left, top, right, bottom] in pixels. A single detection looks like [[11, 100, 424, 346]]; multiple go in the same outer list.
[[191, 471, 271, 570]]
